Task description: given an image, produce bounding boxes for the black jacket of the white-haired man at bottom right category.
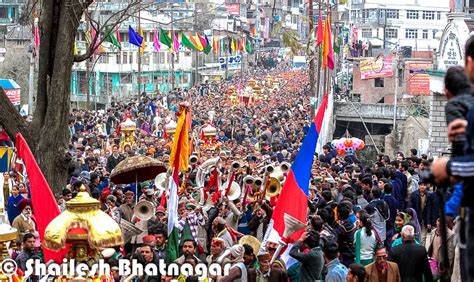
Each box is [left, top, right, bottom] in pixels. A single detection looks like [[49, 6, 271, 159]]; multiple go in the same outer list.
[[390, 241, 433, 282]]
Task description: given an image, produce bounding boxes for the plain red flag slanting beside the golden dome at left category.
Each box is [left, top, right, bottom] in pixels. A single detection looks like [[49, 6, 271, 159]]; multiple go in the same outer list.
[[16, 133, 67, 263]]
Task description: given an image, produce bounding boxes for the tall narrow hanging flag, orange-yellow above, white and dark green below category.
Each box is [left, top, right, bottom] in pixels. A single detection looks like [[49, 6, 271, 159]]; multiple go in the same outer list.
[[166, 108, 189, 261]]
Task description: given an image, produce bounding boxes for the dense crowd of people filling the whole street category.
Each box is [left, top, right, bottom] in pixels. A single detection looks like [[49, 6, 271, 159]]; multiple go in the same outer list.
[[0, 45, 470, 281]]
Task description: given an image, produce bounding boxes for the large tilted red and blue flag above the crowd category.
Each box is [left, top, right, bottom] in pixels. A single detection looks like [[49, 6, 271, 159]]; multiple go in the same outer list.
[[268, 95, 328, 268]]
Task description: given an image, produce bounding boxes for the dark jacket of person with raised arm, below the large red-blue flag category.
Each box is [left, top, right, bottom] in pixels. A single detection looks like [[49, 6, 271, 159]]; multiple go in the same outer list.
[[290, 241, 324, 281]]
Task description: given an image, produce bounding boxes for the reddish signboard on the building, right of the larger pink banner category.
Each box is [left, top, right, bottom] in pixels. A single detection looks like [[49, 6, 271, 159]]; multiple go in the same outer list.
[[407, 62, 433, 95]]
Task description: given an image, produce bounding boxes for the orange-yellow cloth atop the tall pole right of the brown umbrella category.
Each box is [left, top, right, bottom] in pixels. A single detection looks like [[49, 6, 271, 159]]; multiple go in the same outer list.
[[170, 106, 189, 172]]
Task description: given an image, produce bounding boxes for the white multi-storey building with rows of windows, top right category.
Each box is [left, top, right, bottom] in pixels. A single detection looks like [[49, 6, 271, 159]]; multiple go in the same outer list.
[[343, 0, 449, 51]]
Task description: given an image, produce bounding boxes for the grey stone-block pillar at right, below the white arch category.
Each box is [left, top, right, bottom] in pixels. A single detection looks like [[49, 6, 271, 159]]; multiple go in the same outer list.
[[429, 93, 449, 156]]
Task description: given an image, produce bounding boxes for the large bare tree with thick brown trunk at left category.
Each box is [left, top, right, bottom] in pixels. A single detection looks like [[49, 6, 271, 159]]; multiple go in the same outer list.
[[0, 0, 140, 194]]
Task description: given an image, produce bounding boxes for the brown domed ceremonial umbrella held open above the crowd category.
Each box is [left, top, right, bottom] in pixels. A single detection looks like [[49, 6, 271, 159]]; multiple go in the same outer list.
[[110, 155, 167, 202]]
